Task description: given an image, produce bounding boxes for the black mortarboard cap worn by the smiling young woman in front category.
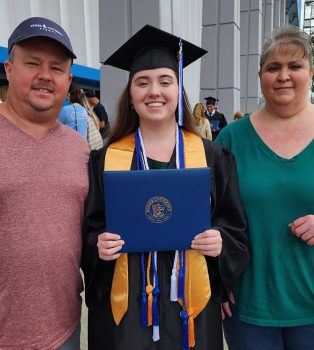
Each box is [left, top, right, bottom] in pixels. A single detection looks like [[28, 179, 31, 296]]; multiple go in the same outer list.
[[104, 24, 207, 75]]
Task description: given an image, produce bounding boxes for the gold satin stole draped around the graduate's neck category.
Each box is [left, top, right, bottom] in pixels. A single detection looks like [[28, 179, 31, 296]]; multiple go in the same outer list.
[[104, 129, 211, 325]]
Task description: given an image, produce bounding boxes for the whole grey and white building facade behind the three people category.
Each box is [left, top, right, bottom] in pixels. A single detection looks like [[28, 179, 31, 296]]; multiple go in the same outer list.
[[0, 0, 302, 121]]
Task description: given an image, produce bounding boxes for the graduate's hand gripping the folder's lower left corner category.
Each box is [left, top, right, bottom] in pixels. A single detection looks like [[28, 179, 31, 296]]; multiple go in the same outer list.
[[97, 232, 124, 261]]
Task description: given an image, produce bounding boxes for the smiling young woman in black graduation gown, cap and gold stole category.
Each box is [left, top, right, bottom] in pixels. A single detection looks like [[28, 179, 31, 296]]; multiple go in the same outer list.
[[82, 25, 250, 350]]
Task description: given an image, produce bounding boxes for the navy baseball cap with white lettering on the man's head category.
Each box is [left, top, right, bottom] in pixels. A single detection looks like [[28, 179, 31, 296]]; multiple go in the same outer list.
[[8, 17, 76, 59]]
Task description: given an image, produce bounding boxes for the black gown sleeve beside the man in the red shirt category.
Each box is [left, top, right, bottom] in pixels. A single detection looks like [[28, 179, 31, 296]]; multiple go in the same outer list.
[[81, 149, 115, 308]]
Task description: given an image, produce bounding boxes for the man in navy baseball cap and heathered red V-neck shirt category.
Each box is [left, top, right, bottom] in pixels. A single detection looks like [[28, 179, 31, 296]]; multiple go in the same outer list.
[[0, 17, 89, 350]]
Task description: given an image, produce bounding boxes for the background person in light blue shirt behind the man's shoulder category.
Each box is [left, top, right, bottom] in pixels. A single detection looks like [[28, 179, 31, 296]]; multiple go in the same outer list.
[[58, 85, 88, 140]]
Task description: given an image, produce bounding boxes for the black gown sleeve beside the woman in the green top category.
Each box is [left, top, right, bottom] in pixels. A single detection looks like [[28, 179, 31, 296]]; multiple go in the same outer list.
[[203, 140, 250, 301]]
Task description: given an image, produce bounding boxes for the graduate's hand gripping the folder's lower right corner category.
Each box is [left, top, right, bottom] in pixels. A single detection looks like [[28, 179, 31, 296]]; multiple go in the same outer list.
[[191, 229, 222, 257]]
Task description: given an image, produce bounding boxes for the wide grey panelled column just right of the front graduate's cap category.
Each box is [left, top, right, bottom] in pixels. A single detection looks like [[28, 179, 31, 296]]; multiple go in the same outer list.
[[201, 0, 240, 121]]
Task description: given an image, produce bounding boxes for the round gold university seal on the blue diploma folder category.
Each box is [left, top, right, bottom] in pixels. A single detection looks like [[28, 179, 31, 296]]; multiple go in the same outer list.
[[145, 196, 172, 224]]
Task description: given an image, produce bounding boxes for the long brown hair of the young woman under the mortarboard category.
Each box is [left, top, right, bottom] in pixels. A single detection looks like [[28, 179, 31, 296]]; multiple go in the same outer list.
[[107, 72, 196, 144]]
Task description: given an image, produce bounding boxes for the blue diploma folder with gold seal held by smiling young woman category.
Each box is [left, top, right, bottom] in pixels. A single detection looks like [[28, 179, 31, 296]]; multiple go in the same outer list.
[[103, 168, 211, 252]]
